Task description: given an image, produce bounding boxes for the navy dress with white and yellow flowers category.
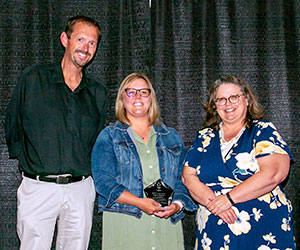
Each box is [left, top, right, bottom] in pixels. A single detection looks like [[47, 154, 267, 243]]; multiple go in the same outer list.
[[185, 120, 296, 250]]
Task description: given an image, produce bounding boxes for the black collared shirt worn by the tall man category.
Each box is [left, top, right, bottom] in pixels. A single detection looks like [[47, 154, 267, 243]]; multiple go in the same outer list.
[[5, 64, 107, 176]]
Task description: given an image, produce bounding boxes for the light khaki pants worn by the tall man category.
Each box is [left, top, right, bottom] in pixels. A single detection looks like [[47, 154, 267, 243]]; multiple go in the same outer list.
[[17, 177, 95, 250]]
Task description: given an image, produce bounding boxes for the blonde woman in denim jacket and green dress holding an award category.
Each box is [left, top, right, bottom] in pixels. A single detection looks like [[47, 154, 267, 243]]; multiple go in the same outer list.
[[92, 73, 195, 250]]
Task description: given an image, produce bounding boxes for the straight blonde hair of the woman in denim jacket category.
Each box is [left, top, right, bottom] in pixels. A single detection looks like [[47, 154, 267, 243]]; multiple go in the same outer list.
[[115, 72, 162, 126]]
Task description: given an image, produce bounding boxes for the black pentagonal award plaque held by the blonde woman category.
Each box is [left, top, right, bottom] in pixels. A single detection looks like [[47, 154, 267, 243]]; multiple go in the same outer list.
[[144, 179, 174, 207]]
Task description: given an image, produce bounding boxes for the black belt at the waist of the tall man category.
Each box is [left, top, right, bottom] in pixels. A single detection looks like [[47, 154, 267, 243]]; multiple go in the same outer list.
[[23, 172, 90, 184]]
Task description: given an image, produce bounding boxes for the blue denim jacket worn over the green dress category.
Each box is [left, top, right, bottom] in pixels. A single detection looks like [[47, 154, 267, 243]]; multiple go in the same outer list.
[[92, 121, 196, 223]]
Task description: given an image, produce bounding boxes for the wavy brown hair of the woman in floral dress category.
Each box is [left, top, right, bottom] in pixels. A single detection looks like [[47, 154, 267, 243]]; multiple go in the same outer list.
[[203, 76, 264, 130]]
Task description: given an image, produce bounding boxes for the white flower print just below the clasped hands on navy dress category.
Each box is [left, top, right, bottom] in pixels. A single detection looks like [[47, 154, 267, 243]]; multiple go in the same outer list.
[[228, 207, 251, 235]]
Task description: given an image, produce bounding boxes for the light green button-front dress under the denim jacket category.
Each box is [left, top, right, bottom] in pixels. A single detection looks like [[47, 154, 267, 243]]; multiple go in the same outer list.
[[102, 127, 184, 250]]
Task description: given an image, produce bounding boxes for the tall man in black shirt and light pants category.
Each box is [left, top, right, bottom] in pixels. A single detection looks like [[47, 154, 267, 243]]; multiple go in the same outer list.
[[5, 16, 107, 250]]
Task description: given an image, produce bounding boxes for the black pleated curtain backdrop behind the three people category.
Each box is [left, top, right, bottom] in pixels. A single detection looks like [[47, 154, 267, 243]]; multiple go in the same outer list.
[[0, 0, 300, 250]]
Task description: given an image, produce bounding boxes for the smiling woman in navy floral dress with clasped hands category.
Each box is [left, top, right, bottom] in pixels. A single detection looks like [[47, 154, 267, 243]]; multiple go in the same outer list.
[[182, 76, 296, 250]]
